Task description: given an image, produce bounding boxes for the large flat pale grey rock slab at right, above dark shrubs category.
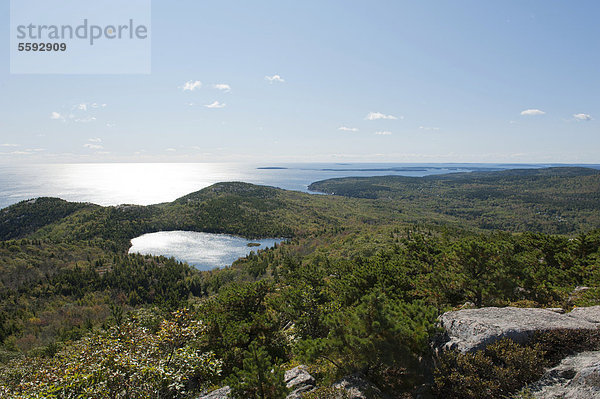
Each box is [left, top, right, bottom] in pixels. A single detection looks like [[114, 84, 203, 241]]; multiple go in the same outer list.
[[440, 306, 600, 352]]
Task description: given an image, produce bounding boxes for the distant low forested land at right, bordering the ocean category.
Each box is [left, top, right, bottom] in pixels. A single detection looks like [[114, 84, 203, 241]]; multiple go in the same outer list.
[[309, 168, 600, 234]]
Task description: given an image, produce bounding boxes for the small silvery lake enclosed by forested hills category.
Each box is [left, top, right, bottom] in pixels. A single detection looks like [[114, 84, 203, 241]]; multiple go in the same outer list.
[[129, 231, 285, 270]]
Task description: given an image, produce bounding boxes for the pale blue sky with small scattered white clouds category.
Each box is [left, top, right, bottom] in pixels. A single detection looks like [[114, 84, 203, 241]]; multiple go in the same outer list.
[[0, 0, 600, 164]]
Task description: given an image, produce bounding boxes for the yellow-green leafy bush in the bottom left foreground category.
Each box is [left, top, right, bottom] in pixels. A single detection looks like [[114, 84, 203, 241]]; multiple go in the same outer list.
[[0, 309, 221, 399]]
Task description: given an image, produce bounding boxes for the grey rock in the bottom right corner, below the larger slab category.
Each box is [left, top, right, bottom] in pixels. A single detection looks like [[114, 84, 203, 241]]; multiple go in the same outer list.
[[529, 352, 600, 399]]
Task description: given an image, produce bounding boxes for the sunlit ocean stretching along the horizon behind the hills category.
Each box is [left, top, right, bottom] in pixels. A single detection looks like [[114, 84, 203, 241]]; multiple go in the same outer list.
[[0, 163, 600, 208]]
